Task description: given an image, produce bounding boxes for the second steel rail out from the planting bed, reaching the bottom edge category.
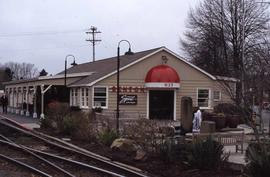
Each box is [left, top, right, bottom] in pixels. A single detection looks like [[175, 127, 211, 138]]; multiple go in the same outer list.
[[0, 136, 124, 177]]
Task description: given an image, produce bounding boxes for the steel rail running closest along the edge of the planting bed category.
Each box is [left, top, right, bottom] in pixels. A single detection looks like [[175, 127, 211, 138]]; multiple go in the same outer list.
[[0, 116, 147, 177]]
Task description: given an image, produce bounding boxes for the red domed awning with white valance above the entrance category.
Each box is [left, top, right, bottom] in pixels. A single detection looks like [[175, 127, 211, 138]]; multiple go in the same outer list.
[[145, 64, 180, 88]]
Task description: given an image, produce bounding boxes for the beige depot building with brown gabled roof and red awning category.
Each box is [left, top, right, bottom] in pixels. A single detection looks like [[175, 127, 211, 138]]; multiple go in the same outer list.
[[5, 47, 237, 120]]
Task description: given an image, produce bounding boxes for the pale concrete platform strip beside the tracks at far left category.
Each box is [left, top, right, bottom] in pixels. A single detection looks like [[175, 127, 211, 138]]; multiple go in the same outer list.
[[0, 113, 40, 129]]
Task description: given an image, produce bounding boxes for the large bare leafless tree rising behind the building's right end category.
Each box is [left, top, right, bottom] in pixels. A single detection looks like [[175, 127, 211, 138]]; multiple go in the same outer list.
[[180, 0, 270, 102]]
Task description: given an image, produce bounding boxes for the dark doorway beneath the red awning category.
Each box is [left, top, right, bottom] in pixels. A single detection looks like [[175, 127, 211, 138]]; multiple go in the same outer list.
[[149, 90, 174, 120]]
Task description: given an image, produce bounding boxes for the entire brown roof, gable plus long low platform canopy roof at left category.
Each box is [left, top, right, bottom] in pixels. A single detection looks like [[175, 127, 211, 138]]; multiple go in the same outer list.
[[5, 47, 223, 87]]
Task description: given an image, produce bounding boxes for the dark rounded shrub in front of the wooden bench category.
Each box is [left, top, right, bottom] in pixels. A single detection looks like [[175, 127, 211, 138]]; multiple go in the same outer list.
[[187, 137, 228, 170]]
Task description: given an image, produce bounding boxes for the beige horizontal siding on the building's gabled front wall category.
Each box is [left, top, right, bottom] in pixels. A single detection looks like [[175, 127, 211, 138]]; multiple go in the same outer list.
[[91, 52, 234, 120]]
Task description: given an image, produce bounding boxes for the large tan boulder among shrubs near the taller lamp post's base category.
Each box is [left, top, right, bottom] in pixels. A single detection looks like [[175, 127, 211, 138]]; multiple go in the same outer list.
[[111, 138, 138, 152]]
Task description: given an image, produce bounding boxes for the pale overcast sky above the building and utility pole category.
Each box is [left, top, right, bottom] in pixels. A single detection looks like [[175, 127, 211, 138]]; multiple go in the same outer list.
[[0, 0, 200, 74]]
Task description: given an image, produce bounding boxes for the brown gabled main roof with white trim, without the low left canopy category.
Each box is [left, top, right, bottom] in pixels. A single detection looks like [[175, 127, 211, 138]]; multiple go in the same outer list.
[[67, 47, 216, 87]]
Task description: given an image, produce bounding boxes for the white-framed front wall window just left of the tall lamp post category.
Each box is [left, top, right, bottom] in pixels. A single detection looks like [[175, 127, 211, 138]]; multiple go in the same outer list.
[[93, 87, 108, 108]]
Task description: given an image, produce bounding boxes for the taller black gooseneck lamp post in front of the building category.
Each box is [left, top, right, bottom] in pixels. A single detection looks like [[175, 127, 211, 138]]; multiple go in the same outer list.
[[116, 40, 133, 135]]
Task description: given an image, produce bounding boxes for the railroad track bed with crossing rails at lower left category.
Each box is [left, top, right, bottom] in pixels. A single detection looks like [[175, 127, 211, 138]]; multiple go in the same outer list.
[[0, 116, 150, 177]]
